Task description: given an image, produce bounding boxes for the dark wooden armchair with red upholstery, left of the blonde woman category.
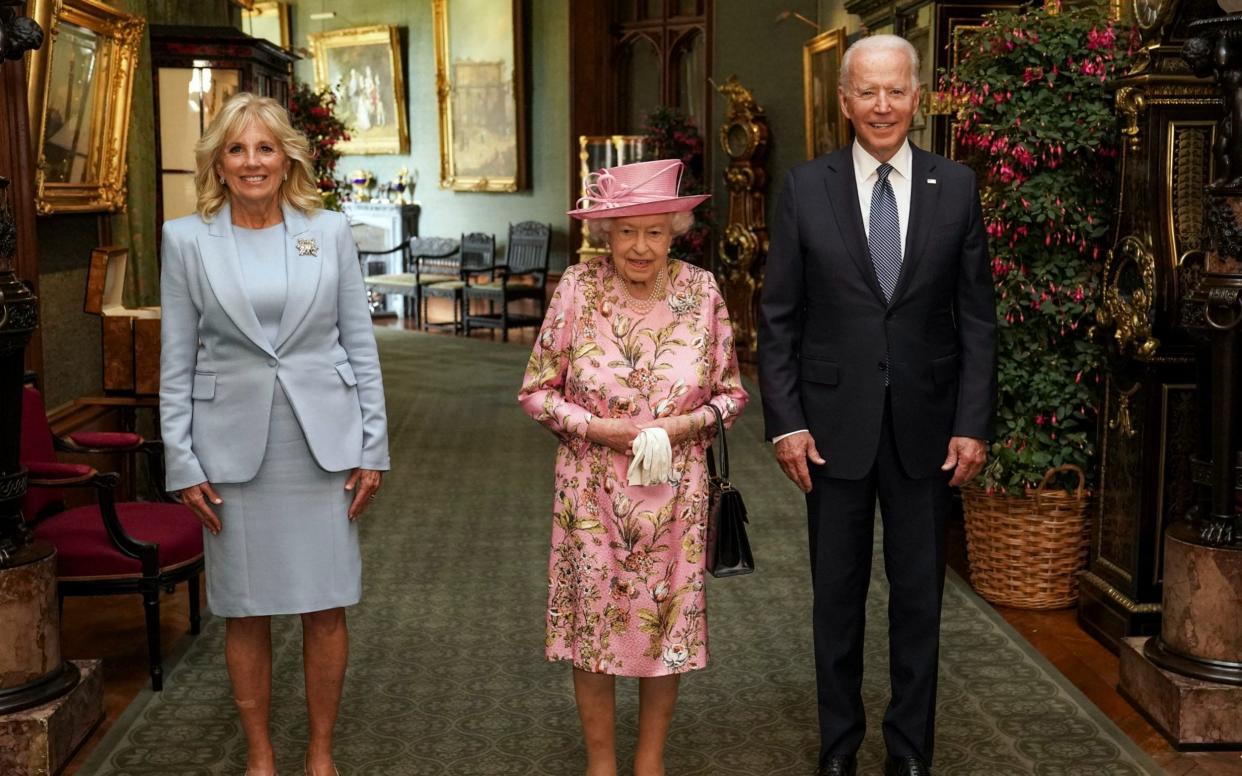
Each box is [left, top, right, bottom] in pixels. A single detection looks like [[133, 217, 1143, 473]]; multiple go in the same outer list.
[[21, 386, 202, 692]]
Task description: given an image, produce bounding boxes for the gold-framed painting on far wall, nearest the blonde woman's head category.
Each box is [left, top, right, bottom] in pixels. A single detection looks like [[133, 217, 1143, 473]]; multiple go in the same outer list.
[[308, 25, 410, 155]]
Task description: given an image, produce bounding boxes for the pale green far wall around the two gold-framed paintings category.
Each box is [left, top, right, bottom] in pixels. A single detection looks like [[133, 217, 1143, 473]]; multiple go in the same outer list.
[[292, 0, 570, 268]]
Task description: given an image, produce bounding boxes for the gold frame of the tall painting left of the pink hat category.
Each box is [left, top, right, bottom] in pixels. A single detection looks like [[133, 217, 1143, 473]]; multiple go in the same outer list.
[[431, 0, 527, 192]]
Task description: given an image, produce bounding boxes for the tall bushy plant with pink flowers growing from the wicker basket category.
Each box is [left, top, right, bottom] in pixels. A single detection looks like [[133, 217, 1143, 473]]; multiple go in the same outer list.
[[940, 5, 1135, 494]]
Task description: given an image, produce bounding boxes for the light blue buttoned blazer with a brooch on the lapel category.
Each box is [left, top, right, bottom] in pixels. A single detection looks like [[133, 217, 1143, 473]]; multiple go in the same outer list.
[[159, 205, 389, 490]]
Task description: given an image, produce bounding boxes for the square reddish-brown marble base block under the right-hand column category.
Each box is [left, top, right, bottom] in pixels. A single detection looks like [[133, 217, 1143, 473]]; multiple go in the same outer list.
[[1118, 636, 1242, 749]]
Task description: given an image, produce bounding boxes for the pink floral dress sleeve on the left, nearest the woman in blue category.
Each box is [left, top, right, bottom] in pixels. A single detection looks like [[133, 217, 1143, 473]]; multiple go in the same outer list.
[[518, 267, 594, 453]]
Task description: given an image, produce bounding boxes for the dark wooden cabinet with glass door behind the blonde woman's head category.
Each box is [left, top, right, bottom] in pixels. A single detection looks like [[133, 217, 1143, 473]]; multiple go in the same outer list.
[[152, 25, 298, 223]]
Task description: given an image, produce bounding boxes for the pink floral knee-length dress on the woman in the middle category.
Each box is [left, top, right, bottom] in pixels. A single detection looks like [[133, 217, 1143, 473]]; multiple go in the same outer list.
[[518, 257, 746, 677]]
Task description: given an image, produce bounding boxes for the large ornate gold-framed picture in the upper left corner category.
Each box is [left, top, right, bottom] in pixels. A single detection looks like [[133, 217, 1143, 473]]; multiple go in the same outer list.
[[26, 0, 147, 215]]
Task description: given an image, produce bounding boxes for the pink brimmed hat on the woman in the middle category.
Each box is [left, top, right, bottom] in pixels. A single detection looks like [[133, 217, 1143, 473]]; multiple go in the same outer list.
[[568, 159, 712, 219]]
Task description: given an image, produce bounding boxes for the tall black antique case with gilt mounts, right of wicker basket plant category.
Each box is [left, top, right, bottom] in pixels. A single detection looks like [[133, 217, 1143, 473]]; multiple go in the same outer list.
[[1078, 0, 1221, 648]]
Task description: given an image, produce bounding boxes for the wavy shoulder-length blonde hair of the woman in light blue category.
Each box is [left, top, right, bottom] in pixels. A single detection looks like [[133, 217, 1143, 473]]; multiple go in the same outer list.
[[194, 92, 323, 221]]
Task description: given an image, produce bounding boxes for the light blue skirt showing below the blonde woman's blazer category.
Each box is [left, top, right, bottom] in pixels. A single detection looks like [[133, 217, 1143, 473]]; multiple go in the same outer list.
[[202, 382, 363, 617]]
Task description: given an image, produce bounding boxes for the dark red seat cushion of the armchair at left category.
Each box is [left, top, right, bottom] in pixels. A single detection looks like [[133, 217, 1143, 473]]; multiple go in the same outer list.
[[35, 502, 202, 579]]
